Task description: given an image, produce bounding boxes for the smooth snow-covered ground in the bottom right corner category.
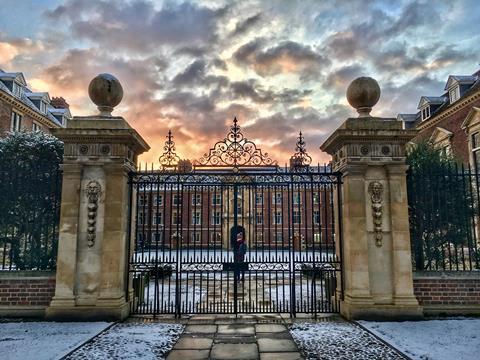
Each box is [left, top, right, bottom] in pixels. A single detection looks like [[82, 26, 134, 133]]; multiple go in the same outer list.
[[360, 318, 480, 360]]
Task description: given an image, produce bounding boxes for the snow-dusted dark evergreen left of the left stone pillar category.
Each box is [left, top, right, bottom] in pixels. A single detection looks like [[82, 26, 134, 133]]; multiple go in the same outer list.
[[0, 131, 63, 270]]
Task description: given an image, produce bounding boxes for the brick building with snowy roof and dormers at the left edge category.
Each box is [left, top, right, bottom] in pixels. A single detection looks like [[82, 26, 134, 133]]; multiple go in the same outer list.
[[0, 69, 72, 137]]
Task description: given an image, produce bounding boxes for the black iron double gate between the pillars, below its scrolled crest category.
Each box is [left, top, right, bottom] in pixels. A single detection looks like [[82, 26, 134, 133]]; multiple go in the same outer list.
[[129, 166, 342, 315]]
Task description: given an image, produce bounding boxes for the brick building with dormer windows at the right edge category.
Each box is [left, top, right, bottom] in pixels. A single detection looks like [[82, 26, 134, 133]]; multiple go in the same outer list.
[[397, 70, 480, 168]]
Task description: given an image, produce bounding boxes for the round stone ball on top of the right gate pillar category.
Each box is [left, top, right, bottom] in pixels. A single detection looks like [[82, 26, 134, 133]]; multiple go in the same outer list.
[[347, 77, 380, 117]]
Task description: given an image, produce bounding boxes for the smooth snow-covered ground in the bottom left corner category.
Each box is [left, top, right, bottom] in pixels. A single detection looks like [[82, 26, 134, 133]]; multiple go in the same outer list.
[[0, 321, 110, 360]]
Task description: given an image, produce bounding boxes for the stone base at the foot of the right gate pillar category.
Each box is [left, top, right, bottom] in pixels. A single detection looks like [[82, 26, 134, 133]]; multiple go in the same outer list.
[[340, 301, 423, 321]]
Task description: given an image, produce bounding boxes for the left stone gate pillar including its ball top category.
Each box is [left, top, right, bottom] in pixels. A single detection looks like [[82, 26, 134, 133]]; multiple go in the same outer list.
[[46, 74, 149, 320]]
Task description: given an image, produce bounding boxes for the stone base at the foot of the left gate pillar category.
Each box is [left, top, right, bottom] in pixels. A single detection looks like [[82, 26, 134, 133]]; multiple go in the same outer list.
[[45, 301, 130, 321]]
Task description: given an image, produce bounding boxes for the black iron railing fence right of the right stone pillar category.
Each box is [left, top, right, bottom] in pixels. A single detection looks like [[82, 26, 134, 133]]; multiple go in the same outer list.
[[407, 164, 480, 271]]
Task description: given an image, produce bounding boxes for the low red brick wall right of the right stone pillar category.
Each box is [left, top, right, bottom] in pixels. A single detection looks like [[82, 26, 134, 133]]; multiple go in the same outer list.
[[413, 271, 480, 315]]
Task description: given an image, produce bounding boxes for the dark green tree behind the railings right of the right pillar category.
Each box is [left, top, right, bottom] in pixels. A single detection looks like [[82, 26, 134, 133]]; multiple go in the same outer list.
[[407, 142, 477, 270]]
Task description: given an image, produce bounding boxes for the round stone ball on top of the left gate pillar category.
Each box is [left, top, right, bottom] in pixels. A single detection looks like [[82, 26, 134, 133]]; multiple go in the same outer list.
[[88, 74, 123, 116]]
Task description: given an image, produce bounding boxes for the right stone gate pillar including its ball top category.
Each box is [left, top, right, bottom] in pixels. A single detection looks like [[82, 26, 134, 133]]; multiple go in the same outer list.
[[320, 77, 423, 319]]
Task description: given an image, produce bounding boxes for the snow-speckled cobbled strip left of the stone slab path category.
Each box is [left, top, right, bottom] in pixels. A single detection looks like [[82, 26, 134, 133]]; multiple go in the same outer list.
[[67, 322, 183, 360]]
